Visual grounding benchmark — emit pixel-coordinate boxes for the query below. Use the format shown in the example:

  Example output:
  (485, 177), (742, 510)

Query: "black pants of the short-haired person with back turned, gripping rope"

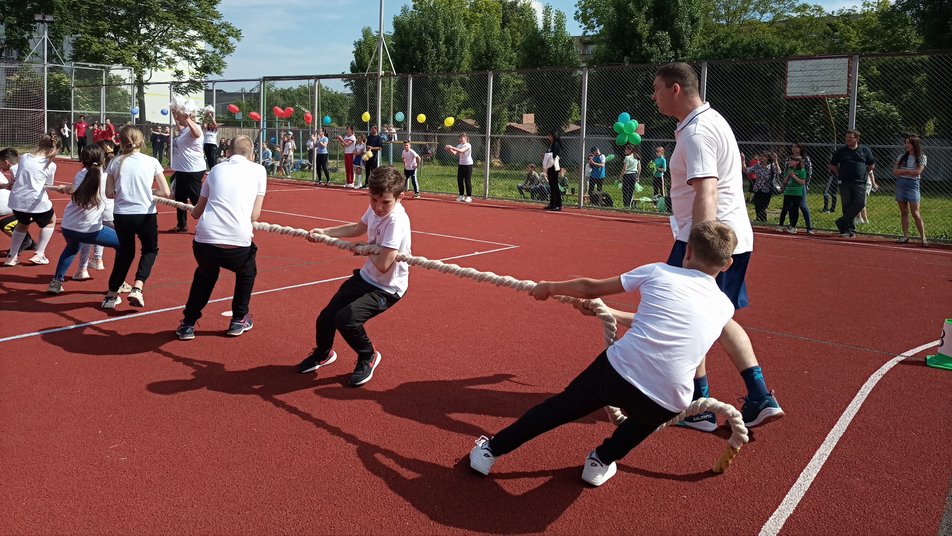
(185, 242), (258, 324)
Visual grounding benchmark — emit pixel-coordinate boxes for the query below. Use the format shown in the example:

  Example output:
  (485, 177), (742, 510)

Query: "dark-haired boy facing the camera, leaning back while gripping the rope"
(298, 167), (410, 387)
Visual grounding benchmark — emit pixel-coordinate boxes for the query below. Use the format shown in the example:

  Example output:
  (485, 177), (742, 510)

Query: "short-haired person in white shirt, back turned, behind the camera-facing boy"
(175, 136), (268, 341)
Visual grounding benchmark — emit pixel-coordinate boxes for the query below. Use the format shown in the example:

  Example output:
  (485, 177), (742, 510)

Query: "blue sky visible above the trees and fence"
(219, 0), (861, 78)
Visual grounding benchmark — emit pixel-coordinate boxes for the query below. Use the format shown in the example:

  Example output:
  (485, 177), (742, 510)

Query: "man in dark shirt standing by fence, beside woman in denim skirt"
(830, 129), (876, 238)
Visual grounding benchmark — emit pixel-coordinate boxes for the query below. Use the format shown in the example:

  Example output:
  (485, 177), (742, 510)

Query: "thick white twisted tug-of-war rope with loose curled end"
(155, 197), (749, 472)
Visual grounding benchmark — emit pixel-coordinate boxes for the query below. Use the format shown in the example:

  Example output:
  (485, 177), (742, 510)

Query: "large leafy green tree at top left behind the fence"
(67, 0), (241, 116)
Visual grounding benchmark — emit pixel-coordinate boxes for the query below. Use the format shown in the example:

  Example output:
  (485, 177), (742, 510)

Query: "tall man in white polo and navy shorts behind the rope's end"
(651, 63), (783, 431)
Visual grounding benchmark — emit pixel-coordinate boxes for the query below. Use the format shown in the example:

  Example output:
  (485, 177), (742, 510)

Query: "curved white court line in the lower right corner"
(760, 340), (939, 536)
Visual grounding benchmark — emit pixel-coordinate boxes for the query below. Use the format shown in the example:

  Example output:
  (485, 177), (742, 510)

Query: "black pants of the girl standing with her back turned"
(109, 214), (159, 292)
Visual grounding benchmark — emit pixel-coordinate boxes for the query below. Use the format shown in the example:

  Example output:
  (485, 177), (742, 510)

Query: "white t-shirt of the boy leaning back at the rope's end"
(608, 263), (734, 413)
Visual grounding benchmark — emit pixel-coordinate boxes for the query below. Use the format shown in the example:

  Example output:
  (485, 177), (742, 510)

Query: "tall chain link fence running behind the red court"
(0, 52), (952, 240)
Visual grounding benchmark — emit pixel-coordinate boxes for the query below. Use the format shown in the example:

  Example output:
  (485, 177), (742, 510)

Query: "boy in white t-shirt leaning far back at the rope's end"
(469, 221), (737, 486)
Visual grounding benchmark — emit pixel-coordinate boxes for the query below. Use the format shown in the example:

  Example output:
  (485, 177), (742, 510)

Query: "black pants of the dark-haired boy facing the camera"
(316, 270), (400, 359)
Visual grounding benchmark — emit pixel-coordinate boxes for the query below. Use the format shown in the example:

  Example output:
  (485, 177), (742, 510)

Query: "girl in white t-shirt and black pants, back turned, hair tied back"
(102, 125), (171, 309)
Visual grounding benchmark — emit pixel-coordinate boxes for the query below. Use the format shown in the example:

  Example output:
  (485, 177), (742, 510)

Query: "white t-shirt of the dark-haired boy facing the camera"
(360, 203), (410, 296)
